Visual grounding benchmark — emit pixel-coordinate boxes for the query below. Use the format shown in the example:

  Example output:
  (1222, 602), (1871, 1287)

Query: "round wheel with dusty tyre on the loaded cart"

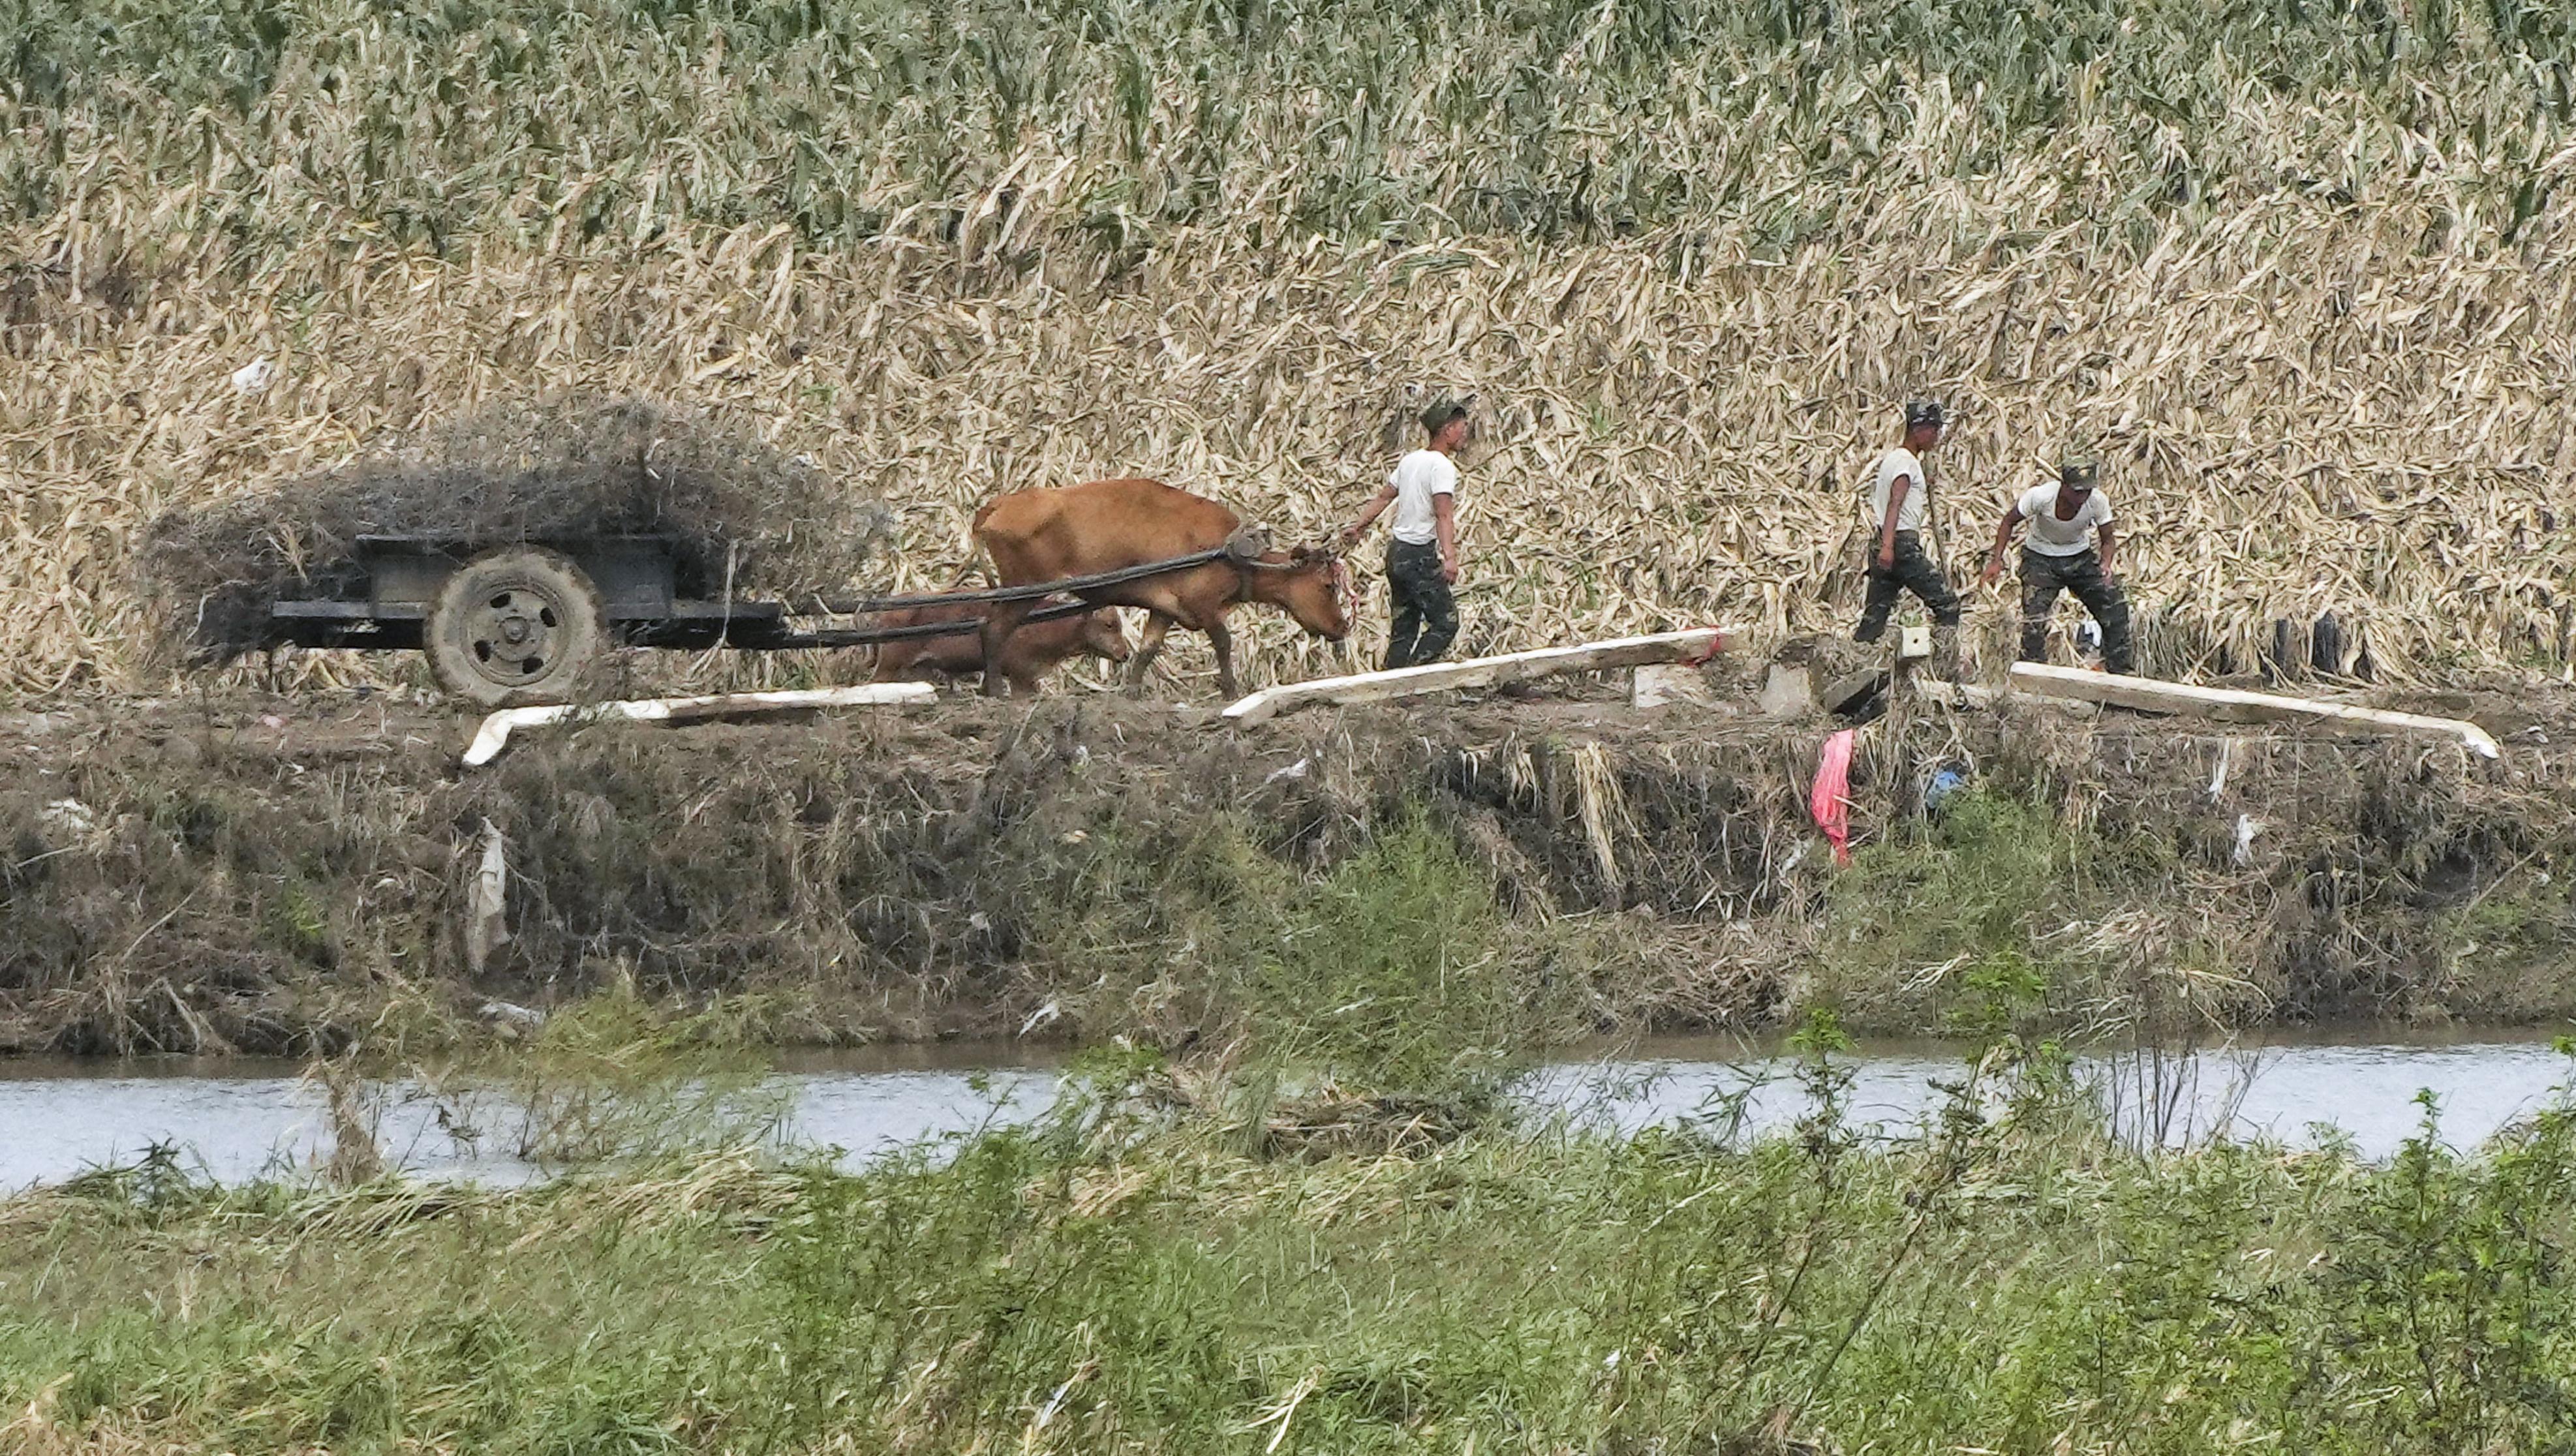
(438, 546), (603, 708)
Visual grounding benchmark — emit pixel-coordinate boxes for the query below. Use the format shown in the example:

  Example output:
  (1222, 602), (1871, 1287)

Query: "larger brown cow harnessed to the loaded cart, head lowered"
(974, 479), (1350, 699)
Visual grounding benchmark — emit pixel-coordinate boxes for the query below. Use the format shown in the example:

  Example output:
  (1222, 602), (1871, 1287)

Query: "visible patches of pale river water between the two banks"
(0, 1033), (2571, 1191)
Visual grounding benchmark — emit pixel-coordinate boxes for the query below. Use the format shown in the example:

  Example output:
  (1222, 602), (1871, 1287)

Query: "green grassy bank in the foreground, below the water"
(0, 1040), (2576, 1456)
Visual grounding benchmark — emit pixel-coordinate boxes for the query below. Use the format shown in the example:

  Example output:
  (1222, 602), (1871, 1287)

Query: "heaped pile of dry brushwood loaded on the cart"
(139, 397), (894, 662)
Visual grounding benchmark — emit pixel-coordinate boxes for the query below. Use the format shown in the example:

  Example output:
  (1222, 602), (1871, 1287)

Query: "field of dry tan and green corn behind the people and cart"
(0, 0), (2576, 696)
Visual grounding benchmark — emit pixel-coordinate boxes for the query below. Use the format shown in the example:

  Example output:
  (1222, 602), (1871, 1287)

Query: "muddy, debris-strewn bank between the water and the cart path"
(0, 696), (2576, 1054)
